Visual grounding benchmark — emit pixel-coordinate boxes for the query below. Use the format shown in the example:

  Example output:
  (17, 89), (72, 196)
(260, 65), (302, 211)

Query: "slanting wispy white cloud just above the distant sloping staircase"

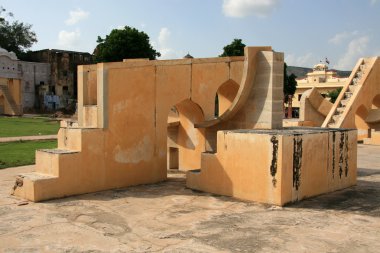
(334, 36), (369, 70)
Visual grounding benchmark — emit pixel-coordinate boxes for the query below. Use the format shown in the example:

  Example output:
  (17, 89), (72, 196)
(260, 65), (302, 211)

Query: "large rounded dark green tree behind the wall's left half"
(94, 26), (161, 62)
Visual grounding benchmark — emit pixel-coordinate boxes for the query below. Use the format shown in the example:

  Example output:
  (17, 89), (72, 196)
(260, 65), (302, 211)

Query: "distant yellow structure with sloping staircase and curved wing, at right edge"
(300, 57), (380, 145)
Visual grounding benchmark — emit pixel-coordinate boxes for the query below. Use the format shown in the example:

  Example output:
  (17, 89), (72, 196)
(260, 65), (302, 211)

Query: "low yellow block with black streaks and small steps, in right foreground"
(187, 128), (357, 205)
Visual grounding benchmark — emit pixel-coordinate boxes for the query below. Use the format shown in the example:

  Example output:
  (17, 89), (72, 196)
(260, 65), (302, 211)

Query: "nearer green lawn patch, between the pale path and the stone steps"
(0, 140), (57, 169)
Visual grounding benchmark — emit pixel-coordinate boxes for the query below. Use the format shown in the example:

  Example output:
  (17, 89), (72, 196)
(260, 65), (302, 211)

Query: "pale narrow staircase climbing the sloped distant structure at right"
(322, 58), (371, 128)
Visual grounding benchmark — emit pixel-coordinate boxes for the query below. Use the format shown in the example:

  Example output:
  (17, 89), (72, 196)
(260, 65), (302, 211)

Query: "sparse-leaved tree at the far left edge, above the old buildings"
(0, 6), (37, 59)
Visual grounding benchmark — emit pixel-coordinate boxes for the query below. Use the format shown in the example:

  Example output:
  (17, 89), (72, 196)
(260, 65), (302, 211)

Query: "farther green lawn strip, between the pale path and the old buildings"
(0, 117), (59, 137)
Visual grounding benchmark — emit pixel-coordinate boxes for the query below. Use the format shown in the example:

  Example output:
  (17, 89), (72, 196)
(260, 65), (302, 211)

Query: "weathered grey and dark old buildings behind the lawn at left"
(0, 48), (93, 115)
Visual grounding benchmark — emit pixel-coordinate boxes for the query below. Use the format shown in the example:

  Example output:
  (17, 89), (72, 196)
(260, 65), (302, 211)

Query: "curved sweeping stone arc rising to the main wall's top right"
(195, 46), (272, 128)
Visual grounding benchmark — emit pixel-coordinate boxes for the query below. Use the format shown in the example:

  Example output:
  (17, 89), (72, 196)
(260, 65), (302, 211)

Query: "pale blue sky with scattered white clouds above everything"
(0, 0), (380, 70)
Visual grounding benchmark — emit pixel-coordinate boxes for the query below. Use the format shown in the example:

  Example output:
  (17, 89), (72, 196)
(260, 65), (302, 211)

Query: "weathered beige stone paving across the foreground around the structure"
(0, 145), (380, 253)
